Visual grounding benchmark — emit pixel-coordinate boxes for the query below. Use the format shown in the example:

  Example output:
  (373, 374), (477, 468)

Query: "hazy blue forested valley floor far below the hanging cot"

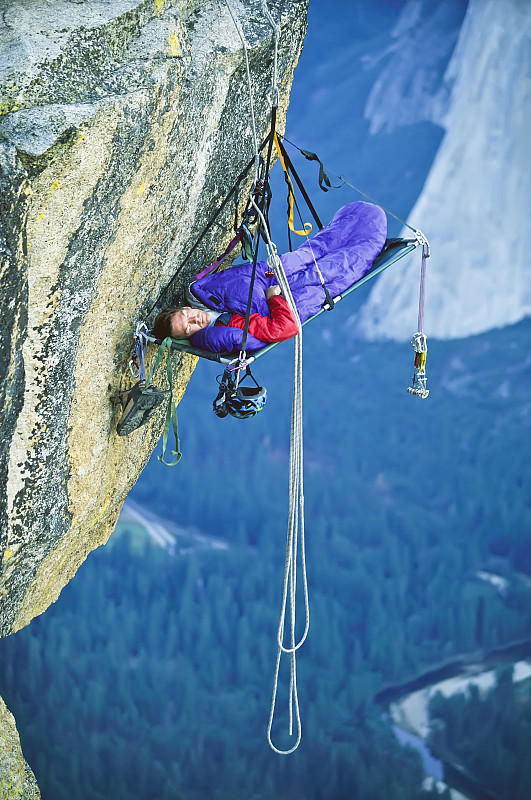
(0, 320), (531, 800)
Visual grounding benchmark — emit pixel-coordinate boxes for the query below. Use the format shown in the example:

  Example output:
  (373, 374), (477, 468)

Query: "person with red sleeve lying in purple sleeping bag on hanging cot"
(153, 202), (387, 352)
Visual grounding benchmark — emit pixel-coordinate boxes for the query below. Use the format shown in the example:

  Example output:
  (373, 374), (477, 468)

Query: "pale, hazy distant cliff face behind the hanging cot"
(355, 0), (531, 340)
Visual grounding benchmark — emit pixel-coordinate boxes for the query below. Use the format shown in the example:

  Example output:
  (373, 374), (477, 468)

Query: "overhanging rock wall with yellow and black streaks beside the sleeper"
(0, 0), (307, 635)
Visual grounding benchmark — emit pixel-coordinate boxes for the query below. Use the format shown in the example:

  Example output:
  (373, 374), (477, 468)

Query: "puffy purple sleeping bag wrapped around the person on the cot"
(190, 202), (387, 352)
